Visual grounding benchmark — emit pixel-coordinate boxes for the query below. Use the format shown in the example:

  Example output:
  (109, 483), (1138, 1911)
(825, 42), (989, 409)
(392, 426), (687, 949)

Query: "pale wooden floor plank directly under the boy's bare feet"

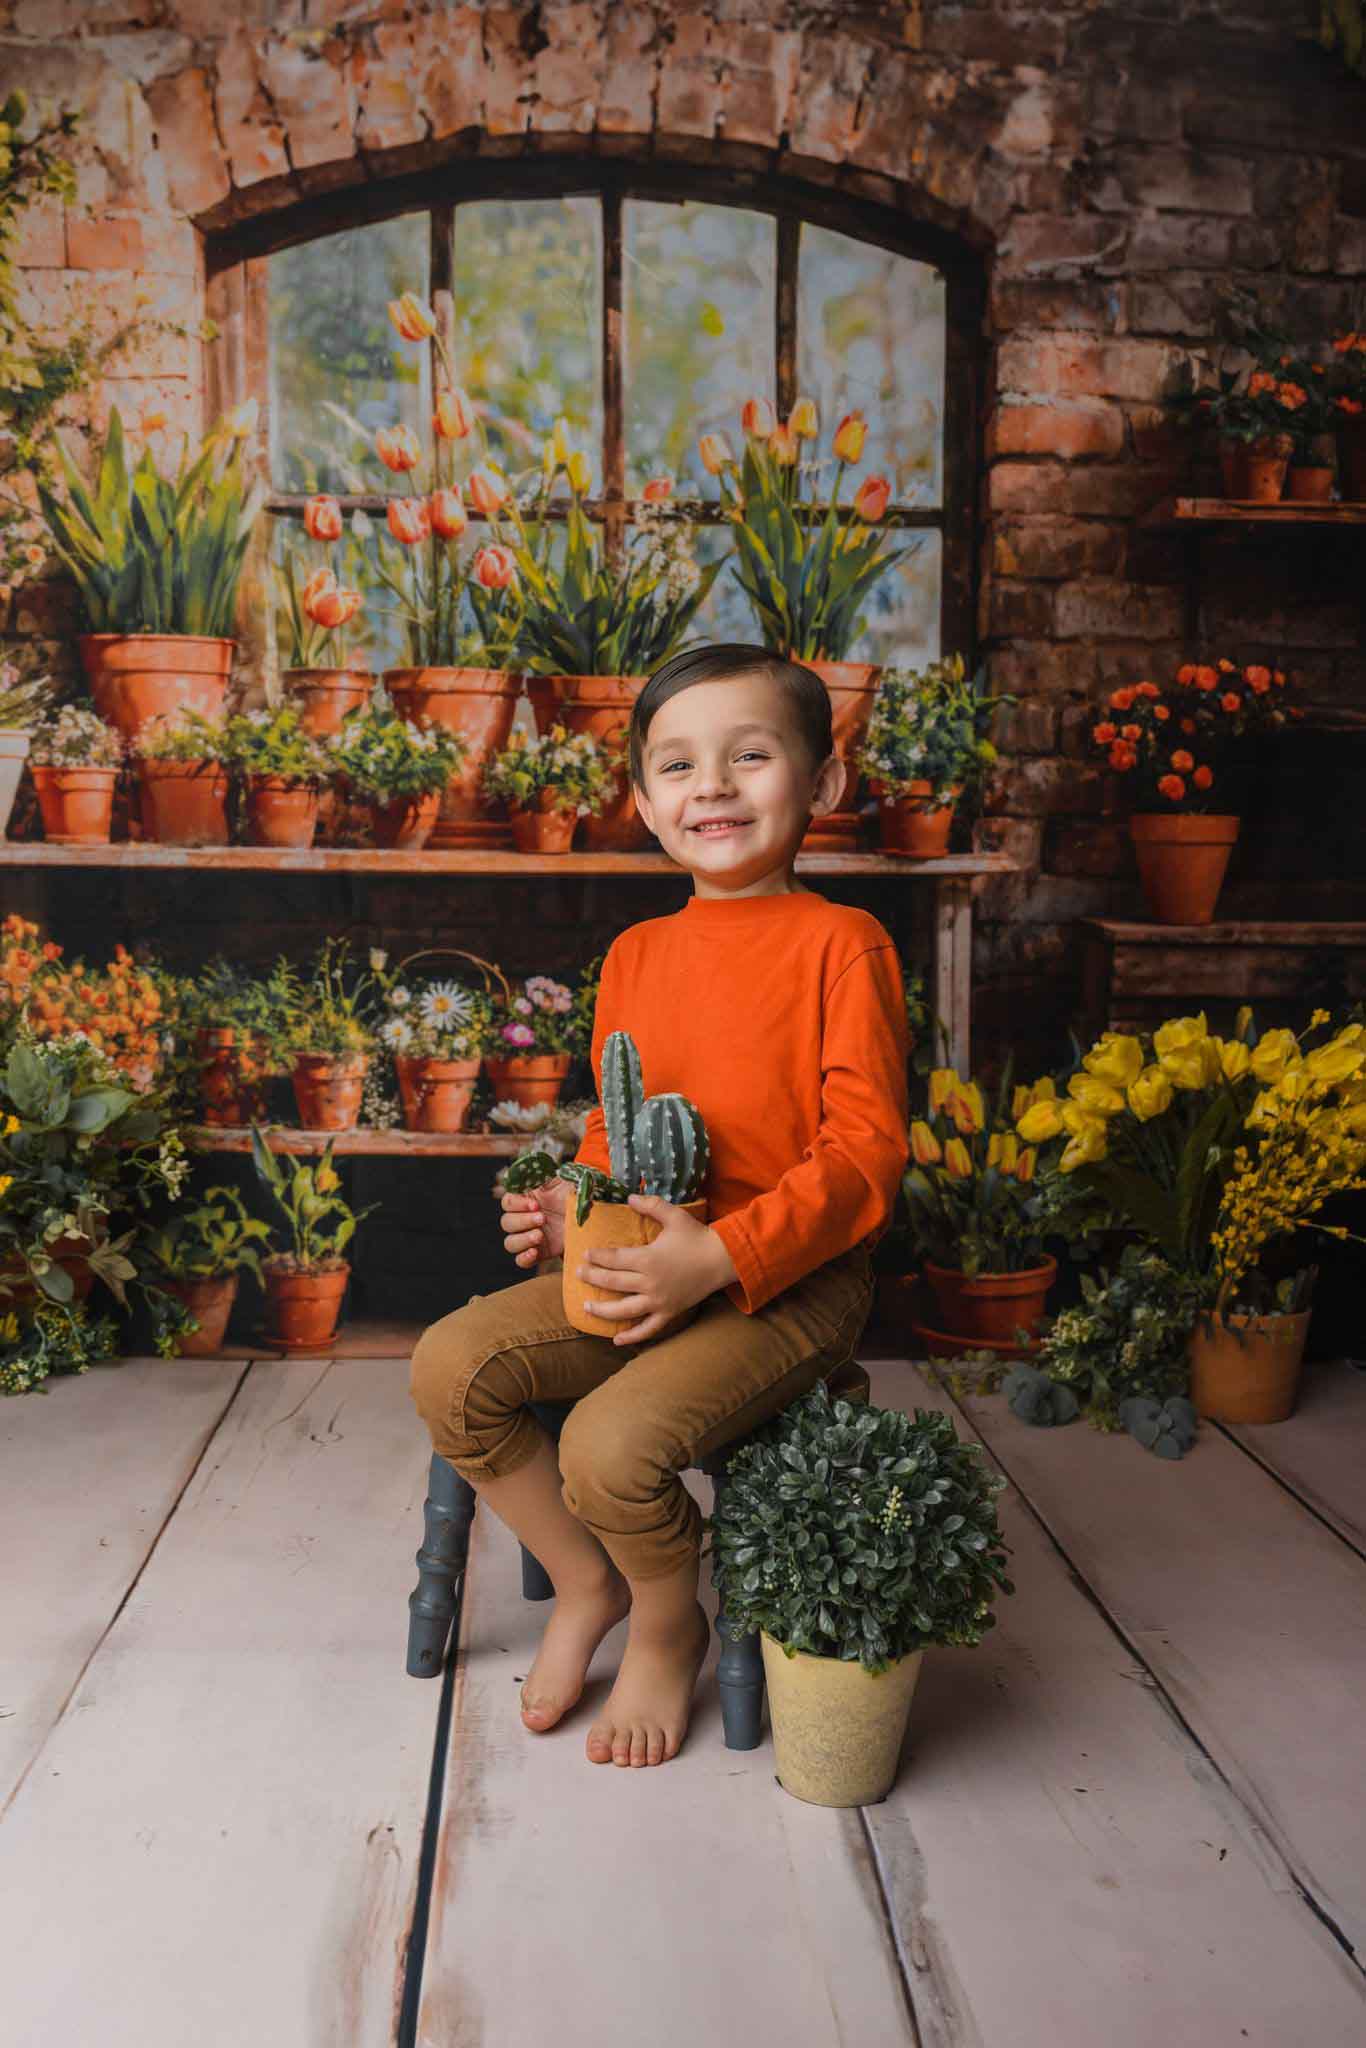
(418, 1473), (913, 2048)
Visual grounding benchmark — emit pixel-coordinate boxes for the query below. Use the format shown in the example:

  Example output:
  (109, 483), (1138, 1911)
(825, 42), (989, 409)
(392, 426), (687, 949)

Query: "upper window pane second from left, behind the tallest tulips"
(455, 199), (602, 489)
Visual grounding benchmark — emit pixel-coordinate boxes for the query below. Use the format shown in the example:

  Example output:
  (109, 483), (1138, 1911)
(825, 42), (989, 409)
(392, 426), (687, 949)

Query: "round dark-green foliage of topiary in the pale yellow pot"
(711, 1382), (1014, 1671)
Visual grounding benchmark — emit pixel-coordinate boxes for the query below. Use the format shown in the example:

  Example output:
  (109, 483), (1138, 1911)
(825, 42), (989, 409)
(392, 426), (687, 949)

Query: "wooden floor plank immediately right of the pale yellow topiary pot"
(866, 1360), (1366, 2048)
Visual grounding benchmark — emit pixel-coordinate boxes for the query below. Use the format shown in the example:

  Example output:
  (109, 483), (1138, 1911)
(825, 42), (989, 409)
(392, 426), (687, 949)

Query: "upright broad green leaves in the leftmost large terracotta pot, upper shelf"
(39, 406), (266, 637)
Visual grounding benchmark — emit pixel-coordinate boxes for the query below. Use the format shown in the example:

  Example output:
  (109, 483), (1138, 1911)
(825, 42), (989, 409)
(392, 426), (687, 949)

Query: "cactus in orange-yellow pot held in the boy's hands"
(555, 1030), (711, 1337)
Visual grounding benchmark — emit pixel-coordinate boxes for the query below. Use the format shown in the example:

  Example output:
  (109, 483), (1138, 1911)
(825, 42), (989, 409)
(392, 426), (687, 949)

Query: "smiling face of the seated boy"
(635, 674), (844, 893)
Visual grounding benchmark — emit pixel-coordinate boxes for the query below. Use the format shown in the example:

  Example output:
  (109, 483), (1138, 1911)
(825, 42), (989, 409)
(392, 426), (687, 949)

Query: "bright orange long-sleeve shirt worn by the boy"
(575, 889), (909, 1315)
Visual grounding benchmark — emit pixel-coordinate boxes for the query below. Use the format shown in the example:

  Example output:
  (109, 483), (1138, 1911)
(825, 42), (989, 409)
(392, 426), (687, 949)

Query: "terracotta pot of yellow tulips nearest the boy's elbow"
(901, 1067), (1057, 1350)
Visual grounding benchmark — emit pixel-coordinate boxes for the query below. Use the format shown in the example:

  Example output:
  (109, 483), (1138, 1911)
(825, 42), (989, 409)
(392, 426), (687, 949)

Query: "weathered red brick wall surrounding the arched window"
(0, 0), (1366, 1059)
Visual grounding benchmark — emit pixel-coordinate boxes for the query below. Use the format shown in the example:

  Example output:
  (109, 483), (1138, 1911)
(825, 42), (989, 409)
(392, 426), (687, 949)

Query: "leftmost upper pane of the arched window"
(268, 213), (428, 492)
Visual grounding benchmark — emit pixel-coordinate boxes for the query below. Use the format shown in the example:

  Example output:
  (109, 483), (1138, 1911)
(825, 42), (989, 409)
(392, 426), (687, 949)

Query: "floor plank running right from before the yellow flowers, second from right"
(933, 1359), (1366, 1964)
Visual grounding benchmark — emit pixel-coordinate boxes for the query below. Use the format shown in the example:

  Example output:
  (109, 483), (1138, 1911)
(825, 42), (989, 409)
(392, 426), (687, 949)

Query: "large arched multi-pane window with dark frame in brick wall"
(209, 160), (977, 664)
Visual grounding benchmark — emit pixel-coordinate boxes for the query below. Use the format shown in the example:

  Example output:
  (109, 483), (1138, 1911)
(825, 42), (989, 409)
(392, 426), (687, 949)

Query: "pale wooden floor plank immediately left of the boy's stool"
(0, 1360), (440, 2048)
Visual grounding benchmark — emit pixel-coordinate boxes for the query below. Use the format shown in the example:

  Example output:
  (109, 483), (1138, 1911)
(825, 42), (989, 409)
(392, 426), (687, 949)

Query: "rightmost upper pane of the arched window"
(797, 223), (946, 506)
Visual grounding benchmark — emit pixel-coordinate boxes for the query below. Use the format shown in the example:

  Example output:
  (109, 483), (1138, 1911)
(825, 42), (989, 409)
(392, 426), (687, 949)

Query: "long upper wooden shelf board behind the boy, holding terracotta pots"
(0, 840), (1016, 881)
